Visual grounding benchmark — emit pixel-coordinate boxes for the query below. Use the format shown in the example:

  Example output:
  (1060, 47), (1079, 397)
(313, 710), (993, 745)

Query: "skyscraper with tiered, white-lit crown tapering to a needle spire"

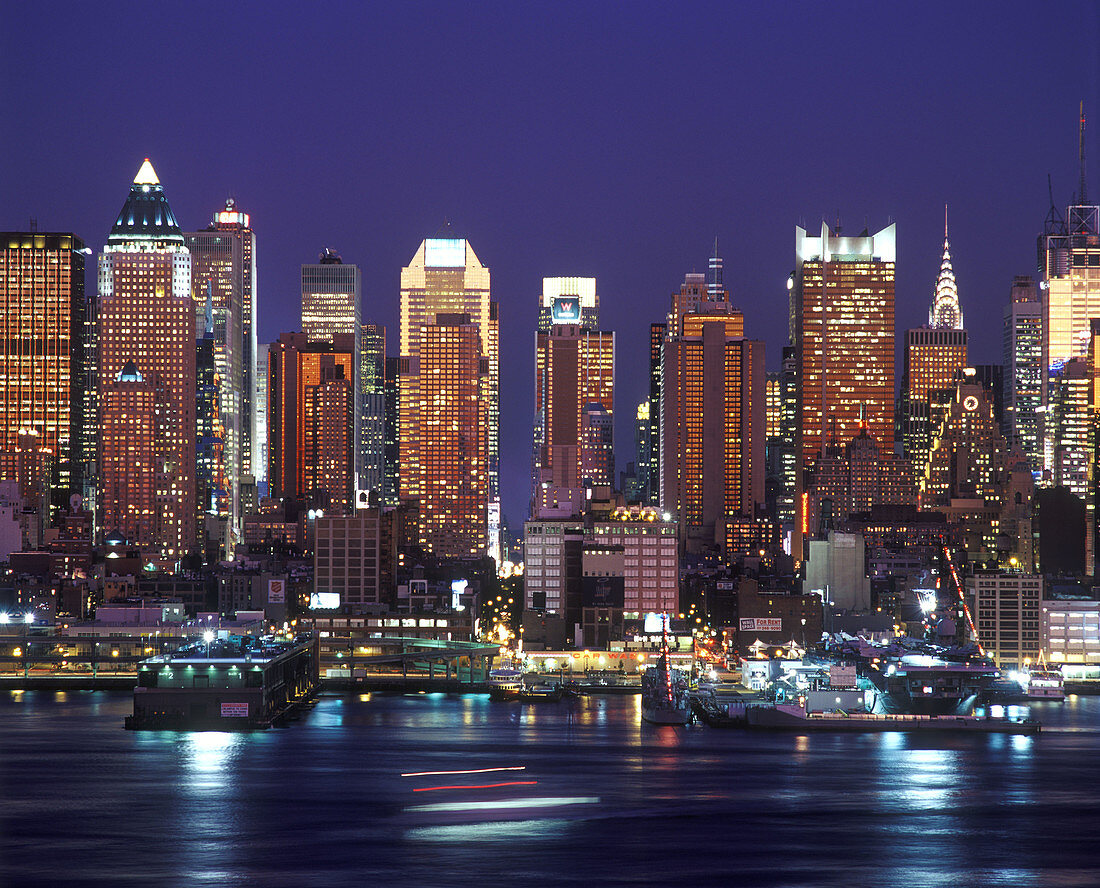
(899, 214), (967, 475)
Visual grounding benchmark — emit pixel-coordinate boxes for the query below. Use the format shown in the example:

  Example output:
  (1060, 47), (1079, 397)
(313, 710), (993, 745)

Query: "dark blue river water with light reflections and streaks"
(0, 692), (1100, 888)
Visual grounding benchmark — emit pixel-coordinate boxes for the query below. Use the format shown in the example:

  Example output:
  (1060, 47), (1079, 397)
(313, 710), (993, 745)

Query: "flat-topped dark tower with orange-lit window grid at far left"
(0, 231), (86, 511)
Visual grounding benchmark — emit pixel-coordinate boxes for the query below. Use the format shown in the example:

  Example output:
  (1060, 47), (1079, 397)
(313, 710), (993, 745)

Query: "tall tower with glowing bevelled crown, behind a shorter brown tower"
(398, 238), (501, 556)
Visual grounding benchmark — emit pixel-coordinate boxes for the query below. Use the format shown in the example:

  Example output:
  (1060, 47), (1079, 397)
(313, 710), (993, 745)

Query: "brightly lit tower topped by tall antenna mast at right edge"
(1038, 103), (1100, 472)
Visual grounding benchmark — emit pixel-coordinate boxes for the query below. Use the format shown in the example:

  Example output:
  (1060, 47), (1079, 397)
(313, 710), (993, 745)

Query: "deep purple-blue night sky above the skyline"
(0, 0), (1100, 529)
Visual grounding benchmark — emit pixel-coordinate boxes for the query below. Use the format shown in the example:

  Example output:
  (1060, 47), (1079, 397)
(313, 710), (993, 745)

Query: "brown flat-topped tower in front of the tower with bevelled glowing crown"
(402, 314), (490, 557)
